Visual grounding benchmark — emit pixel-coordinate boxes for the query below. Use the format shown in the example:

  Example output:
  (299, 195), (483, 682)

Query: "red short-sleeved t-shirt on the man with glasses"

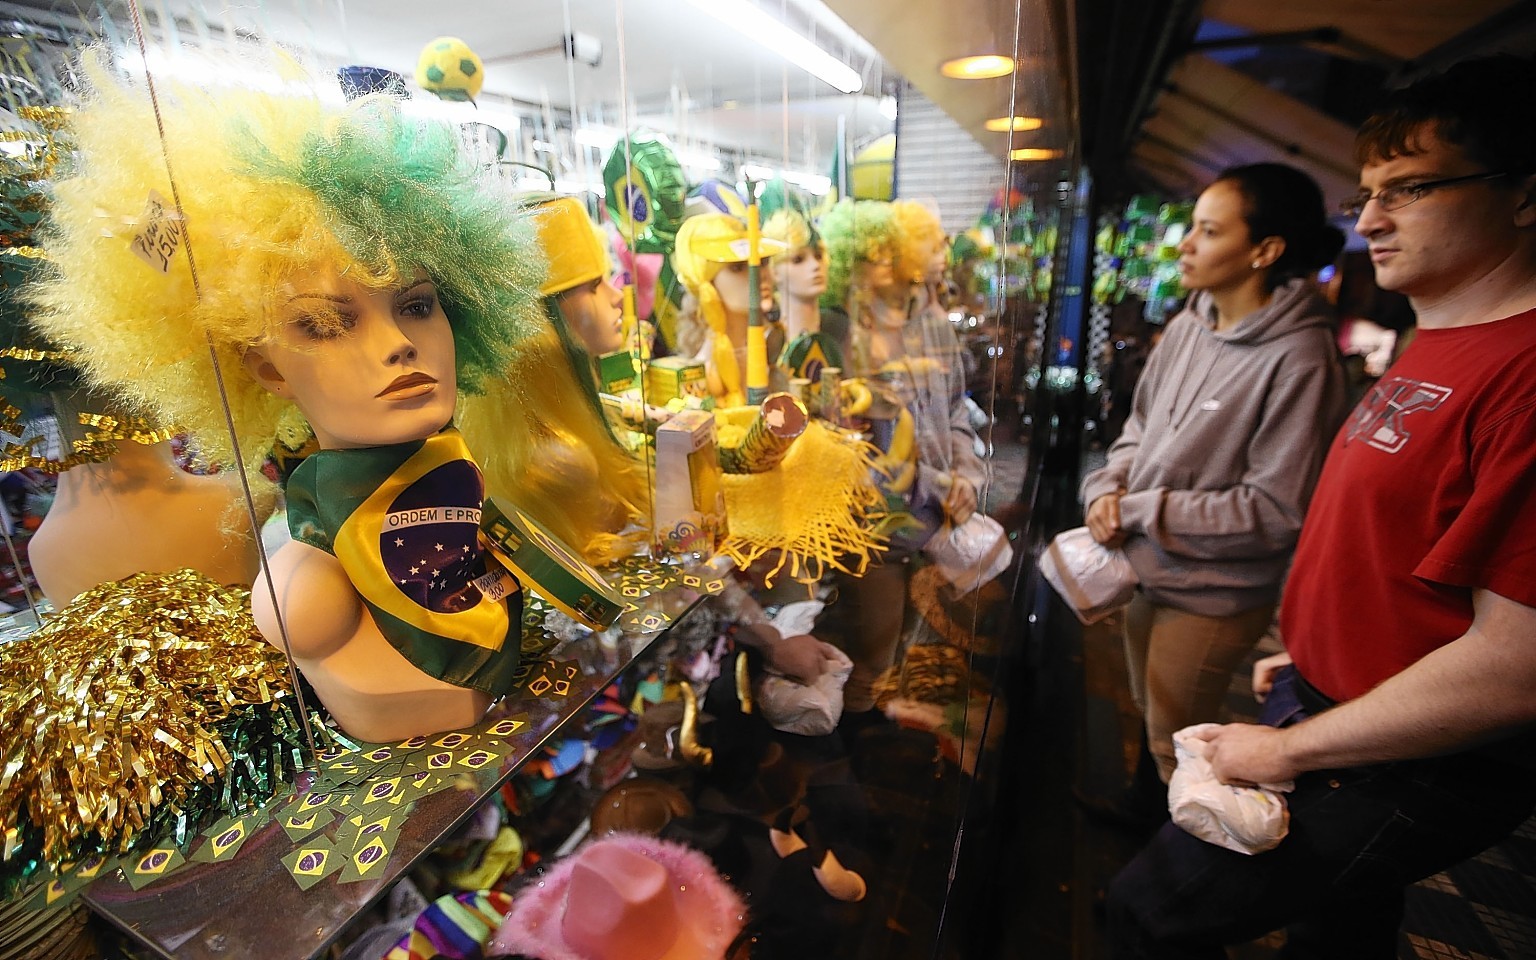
(1281, 310), (1536, 700)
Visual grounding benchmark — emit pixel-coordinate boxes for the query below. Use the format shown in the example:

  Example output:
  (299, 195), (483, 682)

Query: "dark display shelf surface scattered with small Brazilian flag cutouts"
(83, 571), (705, 960)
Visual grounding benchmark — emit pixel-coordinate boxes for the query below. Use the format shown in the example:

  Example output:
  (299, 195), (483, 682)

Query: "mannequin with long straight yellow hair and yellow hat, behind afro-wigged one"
(458, 197), (650, 567)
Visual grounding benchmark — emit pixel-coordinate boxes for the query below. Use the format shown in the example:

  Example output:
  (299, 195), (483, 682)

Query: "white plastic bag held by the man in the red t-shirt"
(1167, 723), (1295, 854)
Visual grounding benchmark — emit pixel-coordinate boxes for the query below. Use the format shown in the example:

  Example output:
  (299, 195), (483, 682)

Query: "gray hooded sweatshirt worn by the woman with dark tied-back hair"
(1083, 278), (1346, 616)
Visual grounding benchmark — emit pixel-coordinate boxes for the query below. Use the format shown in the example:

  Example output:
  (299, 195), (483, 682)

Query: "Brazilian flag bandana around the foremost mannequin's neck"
(286, 427), (522, 696)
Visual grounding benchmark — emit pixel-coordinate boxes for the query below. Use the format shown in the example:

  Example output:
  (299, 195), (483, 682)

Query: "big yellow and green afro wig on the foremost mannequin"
(31, 51), (544, 462)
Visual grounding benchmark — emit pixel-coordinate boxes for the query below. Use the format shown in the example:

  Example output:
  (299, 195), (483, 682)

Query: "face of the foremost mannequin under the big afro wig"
(244, 264), (458, 450)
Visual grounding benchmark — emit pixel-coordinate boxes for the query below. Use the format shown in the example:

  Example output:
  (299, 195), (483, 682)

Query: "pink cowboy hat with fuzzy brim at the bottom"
(487, 833), (746, 960)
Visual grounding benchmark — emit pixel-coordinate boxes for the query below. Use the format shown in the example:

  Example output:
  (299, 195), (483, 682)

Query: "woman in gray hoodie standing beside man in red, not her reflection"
(1083, 163), (1346, 797)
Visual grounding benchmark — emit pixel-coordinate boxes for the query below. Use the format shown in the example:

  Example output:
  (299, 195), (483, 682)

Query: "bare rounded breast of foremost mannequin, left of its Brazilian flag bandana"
(250, 541), (366, 659)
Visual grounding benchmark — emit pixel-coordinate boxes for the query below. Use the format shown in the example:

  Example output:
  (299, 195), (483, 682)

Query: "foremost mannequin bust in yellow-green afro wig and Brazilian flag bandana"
(32, 54), (542, 742)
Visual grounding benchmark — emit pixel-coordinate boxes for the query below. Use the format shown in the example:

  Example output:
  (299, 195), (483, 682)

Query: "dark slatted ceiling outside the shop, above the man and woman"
(1077, 0), (1536, 206)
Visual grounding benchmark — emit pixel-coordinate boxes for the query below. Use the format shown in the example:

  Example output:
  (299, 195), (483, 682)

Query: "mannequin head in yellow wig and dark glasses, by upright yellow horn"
(673, 214), (783, 407)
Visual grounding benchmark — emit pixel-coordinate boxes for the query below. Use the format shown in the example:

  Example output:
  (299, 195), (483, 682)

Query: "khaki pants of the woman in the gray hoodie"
(1126, 593), (1275, 783)
